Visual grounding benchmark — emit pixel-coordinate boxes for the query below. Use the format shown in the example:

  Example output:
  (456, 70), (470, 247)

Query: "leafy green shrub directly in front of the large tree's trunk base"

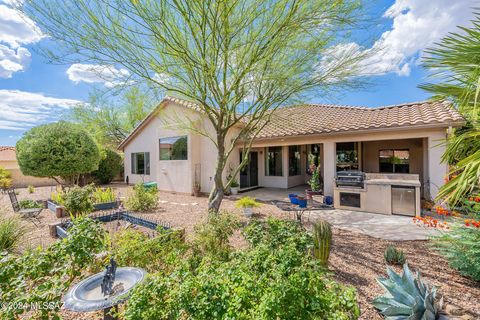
(195, 211), (240, 260)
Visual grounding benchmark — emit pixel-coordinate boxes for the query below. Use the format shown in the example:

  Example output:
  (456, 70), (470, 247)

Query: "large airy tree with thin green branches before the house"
(19, 0), (365, 211)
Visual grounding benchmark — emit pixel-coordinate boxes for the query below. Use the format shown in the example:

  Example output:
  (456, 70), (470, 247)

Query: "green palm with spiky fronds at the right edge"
(421, 12), (480, 205)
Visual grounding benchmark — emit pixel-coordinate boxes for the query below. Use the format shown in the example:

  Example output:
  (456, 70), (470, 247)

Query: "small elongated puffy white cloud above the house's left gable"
(67, 63), (130, 88)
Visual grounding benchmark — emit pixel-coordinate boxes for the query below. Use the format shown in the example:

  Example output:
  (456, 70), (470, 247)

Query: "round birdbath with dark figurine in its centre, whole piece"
(64, 258), (147, 320)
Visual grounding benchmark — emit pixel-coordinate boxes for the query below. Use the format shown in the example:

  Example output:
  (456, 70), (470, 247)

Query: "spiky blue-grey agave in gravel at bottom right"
(372, 263), (442, 320)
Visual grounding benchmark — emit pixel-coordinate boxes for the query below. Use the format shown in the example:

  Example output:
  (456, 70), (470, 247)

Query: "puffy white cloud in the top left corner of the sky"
(0, 0), (44, 78)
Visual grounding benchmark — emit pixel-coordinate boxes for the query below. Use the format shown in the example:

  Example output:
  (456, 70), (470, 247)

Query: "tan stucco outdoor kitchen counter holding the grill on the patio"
(334, 173), (421, 216)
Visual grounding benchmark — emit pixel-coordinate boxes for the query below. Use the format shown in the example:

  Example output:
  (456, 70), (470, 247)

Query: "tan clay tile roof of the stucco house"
(118, 97), (464, 149)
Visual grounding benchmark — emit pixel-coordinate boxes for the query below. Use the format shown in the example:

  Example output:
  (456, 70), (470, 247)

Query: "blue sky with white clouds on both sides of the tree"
(0, 0), (480, 145)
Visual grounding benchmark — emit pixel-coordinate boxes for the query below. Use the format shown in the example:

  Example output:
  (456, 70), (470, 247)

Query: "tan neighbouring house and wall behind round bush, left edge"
(0, 146), (56, 187)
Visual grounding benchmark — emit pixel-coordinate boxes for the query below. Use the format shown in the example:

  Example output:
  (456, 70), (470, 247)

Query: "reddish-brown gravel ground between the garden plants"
(0, 185), (480, 319)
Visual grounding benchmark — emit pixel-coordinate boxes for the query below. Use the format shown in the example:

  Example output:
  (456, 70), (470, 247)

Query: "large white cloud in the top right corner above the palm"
(354, 0), (474, 76)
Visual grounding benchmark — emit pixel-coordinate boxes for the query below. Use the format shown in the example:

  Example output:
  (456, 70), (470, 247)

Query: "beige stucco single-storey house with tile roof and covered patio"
(119, 97), (464, 212)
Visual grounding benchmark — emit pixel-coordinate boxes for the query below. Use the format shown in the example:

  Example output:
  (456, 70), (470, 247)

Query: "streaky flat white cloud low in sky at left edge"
(0, 90), (81, 130)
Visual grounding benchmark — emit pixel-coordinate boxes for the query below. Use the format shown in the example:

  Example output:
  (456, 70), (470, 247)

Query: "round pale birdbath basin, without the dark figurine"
(63, 267), (147, 312)
